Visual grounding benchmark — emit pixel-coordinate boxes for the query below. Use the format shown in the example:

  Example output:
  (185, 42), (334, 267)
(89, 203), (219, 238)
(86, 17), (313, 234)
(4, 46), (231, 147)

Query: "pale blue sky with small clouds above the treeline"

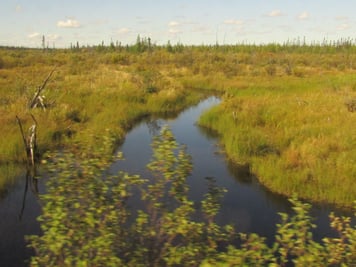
(0, 0), (356, 48)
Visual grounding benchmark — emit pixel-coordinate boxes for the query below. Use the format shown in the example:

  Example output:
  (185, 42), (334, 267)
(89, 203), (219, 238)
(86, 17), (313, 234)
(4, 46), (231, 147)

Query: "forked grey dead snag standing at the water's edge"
(16, 114), (37, 166)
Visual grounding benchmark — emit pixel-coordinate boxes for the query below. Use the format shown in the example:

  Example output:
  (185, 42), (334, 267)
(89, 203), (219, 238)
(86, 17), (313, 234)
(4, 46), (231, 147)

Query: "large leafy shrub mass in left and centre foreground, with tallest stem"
(30, 128), (232, 266)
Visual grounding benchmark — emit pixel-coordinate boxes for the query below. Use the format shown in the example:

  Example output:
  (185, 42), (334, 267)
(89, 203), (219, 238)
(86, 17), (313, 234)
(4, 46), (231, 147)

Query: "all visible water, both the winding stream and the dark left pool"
(0, 98), (352, 267)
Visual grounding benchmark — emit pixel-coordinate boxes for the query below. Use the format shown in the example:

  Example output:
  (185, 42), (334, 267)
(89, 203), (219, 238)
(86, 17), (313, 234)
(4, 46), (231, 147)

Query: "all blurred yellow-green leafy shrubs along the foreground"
(29, 128), (356, 266)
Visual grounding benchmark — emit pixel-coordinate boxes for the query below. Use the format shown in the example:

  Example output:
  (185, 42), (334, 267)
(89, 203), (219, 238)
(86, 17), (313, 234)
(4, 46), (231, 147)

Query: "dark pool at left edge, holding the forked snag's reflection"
(0, 171), (44, 267)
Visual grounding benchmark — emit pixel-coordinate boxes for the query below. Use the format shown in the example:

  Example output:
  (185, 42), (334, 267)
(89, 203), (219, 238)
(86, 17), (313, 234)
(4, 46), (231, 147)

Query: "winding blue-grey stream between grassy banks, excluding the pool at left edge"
(112, 97), (352, 243)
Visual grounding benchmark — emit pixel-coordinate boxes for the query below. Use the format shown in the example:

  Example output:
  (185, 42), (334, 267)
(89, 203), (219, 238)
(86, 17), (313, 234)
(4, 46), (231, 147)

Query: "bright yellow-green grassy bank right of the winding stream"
(200, 73), (356, 209)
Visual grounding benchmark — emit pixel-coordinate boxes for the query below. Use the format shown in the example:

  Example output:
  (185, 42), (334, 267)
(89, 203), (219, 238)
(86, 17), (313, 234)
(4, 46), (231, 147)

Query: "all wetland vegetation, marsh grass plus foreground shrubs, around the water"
(0, 39), (356, 266)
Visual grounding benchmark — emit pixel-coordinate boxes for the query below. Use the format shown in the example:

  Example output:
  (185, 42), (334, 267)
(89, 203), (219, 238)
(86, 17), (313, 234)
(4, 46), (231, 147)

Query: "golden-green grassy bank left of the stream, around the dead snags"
(0, 49), (210, 162)
